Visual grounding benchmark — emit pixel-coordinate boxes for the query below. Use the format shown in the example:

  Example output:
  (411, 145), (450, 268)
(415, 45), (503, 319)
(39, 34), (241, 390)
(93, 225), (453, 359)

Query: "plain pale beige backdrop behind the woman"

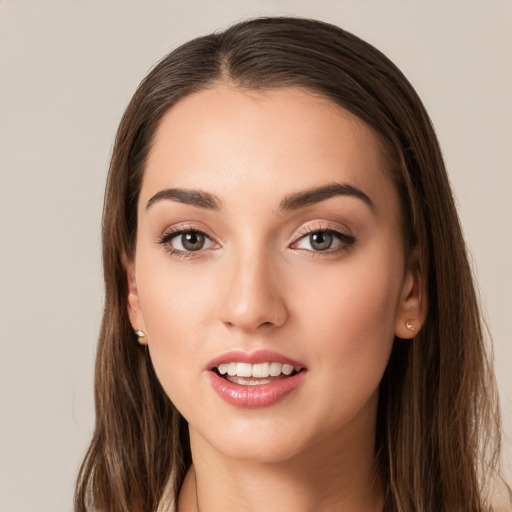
(0, 0), (512, 512)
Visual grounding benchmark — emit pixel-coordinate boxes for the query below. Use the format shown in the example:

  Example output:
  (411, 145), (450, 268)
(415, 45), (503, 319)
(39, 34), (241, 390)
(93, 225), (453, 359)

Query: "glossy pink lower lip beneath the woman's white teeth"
(208, 370), (306, 409)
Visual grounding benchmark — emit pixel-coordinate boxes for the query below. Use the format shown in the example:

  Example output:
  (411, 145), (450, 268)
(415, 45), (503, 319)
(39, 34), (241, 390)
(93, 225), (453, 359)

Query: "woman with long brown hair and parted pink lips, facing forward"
(76, 18), (506, 512)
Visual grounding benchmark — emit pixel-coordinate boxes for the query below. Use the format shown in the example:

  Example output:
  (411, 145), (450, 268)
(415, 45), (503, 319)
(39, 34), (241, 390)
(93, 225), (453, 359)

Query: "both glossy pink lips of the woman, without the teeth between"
(205, 350), (307, 409)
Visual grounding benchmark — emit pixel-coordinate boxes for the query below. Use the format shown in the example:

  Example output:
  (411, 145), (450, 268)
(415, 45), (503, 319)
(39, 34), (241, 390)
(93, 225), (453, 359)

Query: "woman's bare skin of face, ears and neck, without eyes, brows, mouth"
(127, 84), (425, 512)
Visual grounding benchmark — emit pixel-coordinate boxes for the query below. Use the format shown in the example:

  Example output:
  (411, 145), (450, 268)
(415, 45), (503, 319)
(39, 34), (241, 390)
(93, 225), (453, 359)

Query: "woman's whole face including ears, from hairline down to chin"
(128, 85), (420, 461)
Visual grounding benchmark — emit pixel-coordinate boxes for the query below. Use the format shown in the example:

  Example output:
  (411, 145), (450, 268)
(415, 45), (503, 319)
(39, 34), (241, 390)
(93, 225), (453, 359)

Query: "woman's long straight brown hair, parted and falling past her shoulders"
(75, 18), (499, 512)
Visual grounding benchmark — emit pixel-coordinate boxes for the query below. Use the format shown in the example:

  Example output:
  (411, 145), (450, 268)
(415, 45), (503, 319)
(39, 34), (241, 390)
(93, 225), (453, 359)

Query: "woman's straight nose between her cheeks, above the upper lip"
(221, 247), (289, 333)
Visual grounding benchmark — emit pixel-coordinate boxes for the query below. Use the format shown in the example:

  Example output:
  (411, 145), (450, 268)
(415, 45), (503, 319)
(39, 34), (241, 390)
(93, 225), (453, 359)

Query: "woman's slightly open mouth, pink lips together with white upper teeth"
(205, 350), (307, 408)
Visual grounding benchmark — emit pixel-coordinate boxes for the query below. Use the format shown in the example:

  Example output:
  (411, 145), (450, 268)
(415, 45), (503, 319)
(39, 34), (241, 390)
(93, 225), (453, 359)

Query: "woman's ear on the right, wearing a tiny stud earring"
(395, 248), (427, 339)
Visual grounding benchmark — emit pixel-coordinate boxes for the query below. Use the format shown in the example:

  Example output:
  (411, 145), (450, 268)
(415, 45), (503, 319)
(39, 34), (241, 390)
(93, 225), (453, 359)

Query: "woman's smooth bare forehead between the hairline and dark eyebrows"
(141, 85), (397, 216)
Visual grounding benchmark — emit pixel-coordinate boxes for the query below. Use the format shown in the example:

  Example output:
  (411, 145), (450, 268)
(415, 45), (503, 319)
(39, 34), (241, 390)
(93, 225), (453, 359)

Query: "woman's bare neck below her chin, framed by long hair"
(178, 422), (383, 512)
